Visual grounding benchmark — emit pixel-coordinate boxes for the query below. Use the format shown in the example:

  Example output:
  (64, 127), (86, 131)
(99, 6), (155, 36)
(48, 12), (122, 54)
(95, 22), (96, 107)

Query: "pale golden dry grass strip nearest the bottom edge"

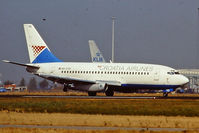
(0, 112), (199, 129)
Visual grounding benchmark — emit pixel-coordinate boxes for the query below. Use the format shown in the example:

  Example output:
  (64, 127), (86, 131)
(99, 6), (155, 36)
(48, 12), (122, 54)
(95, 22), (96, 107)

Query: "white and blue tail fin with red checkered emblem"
(24, 24), (62, 63)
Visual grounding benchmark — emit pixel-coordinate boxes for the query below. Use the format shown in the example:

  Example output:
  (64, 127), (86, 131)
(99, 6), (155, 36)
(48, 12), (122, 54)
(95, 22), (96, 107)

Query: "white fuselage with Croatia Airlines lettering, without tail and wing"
(35, 62), (188, 89)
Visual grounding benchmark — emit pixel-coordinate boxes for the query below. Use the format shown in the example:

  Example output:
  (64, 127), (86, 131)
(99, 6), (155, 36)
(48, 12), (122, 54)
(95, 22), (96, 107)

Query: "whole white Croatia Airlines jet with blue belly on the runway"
(3, 24), (189, 96)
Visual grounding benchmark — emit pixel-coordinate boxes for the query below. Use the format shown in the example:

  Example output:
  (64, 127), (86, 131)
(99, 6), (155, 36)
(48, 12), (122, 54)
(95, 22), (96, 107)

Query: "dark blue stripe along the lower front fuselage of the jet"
(122, 84), (179, 89)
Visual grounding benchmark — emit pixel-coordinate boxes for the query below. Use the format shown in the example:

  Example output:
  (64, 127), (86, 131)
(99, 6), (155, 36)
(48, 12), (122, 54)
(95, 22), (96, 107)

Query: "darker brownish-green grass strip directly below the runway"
(0, 98), (199, 117)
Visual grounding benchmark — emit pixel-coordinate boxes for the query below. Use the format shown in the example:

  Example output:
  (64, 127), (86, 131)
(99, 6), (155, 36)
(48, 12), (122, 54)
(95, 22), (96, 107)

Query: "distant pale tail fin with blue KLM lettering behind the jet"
(88, 40), (106, 62)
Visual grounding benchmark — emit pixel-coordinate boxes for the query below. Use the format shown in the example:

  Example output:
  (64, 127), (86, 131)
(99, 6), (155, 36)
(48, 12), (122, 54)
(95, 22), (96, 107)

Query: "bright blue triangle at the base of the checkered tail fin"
(32, 48), (62, 63)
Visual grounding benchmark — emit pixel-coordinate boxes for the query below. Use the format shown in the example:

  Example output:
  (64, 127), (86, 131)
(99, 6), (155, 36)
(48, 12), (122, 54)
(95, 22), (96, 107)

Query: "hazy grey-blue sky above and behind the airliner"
(0, 0), (199, 82)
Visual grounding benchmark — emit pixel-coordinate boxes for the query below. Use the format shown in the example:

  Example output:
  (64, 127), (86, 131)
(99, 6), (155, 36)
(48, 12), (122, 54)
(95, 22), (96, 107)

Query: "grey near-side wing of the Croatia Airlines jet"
(38, 74), (121, 86)
